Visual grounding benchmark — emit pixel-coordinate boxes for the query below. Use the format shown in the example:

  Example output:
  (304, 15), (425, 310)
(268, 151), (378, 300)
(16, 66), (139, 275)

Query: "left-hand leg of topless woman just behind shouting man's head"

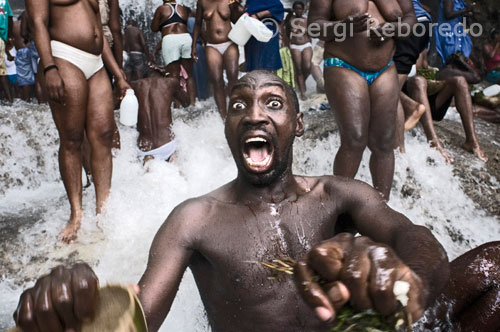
(205, 46), (226, 119)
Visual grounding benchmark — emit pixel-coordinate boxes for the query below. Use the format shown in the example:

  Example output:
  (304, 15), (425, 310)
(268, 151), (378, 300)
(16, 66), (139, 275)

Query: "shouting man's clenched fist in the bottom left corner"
(14, 264), (99, 332)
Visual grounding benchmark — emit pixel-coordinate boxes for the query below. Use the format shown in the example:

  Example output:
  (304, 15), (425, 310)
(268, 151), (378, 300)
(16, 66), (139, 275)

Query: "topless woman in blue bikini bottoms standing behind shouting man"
(308, 0), (416, 199)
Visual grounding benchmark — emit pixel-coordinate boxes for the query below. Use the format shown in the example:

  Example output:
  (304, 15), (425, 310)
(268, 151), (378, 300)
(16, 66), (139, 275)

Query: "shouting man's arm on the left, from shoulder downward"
(139, 200), (203, 332)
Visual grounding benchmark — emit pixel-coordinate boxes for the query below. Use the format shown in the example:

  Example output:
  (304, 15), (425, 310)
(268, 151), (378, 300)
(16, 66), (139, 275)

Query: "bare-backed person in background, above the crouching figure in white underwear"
(123, 20), (150, 82)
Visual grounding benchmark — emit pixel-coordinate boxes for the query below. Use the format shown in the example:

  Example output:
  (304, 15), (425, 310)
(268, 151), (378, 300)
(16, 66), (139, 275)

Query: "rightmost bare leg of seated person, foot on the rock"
(436, 76), (488, 162)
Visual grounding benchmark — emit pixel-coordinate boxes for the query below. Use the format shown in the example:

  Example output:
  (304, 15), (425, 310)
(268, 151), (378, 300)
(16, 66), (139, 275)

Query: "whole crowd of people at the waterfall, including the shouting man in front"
(0, 0), (500, 332)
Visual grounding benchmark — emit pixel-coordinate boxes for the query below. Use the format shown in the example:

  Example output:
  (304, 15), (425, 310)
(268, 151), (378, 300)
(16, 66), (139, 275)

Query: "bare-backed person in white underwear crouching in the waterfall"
(131, 70), (189, 161)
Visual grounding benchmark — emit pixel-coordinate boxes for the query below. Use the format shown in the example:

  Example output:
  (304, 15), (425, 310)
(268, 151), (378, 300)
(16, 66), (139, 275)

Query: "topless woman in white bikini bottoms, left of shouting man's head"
(192, 0), (240, 118)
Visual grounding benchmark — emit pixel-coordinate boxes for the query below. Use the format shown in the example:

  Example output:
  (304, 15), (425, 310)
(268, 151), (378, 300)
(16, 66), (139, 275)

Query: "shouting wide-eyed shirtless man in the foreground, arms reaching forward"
(12, 71), (448, 332)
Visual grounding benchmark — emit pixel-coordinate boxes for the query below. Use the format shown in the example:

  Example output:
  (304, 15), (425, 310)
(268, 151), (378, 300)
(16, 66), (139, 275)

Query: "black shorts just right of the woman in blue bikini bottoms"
(394, 21), (431, 75)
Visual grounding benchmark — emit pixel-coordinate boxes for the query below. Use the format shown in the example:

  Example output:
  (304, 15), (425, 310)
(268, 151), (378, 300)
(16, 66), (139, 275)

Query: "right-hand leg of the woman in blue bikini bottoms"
(368, 64), (400, 200)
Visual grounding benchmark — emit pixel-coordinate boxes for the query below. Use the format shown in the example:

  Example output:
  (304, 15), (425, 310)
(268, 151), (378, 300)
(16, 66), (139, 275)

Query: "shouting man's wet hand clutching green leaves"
(295, 233), (427, 322)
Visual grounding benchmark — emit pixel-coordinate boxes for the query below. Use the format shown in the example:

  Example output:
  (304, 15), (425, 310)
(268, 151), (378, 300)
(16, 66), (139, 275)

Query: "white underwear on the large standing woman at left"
(50, 40), (104, 79)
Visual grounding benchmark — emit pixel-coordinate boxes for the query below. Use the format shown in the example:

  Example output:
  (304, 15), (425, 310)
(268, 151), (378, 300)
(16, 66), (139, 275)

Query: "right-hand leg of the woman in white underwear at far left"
(86, 68), (115, 214)
